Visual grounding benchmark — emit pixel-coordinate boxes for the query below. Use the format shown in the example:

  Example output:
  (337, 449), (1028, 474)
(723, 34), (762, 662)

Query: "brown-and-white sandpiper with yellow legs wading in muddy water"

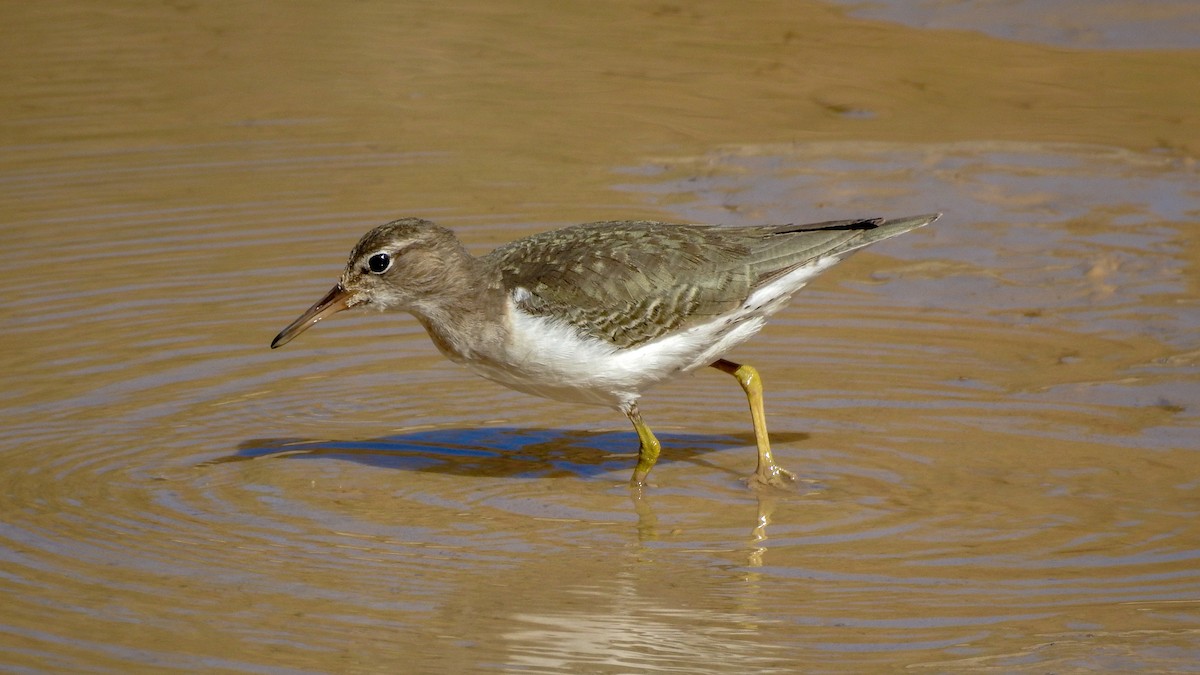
(271, 214), (941, 486)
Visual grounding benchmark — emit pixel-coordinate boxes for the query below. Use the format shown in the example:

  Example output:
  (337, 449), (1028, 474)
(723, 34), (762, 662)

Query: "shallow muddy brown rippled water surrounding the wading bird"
(0, 2), (1200, 673)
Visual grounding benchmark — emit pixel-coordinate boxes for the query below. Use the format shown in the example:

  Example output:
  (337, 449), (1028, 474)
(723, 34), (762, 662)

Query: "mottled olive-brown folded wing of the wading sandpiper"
(488, 216), (936, 347)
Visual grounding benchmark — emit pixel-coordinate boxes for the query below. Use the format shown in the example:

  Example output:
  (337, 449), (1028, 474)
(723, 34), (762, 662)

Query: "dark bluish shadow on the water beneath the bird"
(218, 426), (809, 478)
